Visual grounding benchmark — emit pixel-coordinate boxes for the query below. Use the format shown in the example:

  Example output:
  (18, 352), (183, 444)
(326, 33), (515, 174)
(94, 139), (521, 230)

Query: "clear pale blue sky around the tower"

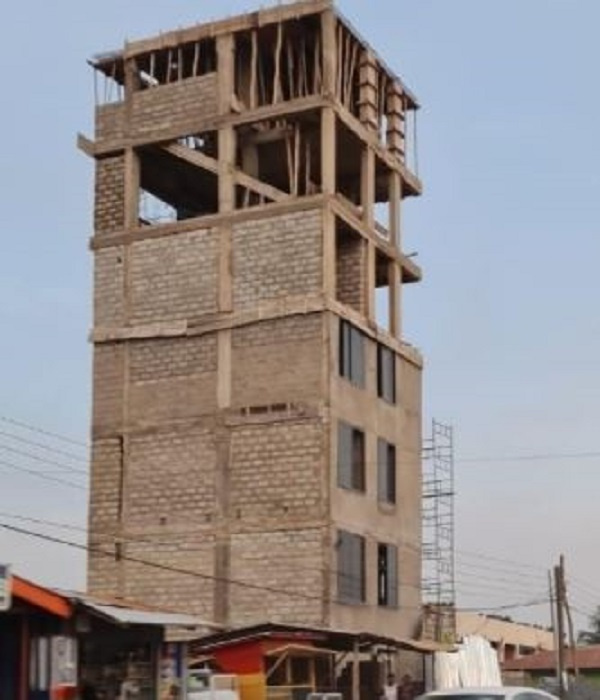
(0, 0), (600, 620)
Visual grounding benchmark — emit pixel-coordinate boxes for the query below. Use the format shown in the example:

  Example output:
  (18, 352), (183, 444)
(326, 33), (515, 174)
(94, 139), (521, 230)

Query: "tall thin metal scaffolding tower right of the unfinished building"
(423, 420), (456, 641)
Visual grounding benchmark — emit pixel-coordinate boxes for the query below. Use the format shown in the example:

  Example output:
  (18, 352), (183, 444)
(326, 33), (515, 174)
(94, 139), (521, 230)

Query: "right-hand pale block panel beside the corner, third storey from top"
(233, 210), (323, 309)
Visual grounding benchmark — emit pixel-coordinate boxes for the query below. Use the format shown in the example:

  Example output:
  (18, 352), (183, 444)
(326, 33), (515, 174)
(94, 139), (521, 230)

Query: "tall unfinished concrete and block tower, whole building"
(79, 0), (422, 637)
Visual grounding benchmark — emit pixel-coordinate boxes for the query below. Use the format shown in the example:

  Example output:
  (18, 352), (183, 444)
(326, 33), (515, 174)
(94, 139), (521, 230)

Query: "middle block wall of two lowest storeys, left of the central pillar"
(125, 428), (216, 619)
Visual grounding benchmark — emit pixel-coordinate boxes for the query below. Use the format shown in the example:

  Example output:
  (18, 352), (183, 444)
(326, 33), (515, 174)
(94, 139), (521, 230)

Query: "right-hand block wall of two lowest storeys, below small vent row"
(229, 420), (325, 624)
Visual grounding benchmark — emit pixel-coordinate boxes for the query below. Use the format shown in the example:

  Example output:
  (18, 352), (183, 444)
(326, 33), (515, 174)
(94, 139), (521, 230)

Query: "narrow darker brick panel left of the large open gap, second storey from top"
(94, 155), (125, 234)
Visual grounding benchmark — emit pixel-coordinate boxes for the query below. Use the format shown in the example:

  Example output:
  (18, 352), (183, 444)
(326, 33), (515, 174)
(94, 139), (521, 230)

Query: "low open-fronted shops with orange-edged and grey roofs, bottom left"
(0, 576), (214, 700)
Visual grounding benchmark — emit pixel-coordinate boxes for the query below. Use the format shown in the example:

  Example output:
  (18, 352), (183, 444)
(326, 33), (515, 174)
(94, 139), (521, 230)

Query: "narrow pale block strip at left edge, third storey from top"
(94, 246), (125, 326)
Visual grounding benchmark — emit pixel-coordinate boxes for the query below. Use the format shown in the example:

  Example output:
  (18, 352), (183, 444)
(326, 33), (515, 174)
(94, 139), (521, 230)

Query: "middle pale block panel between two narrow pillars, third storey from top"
(130, 229), (218, 323)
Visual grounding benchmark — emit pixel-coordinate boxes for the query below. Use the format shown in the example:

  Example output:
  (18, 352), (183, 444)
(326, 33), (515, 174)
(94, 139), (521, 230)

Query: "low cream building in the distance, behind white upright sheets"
(456, 612), (554, 663)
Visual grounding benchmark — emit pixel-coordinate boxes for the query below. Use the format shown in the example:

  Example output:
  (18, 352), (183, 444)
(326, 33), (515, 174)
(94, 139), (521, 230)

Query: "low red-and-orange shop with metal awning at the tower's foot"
(189, 623), (448, 700)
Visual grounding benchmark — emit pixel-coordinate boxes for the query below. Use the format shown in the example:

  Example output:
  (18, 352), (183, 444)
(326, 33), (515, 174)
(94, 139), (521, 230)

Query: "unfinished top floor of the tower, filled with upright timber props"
(91, 0), (418, 170)
